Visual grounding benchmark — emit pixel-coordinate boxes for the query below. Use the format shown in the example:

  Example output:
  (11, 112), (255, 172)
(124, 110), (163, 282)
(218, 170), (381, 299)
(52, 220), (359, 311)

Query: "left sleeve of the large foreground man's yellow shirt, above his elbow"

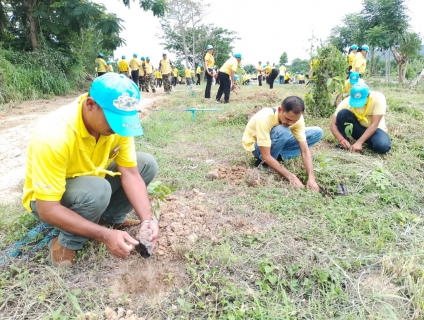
(31, 140), (70, 201)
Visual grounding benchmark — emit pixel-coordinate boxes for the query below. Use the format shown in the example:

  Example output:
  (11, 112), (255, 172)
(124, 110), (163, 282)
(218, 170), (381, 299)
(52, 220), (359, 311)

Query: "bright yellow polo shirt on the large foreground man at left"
(22, 94), (137, 212)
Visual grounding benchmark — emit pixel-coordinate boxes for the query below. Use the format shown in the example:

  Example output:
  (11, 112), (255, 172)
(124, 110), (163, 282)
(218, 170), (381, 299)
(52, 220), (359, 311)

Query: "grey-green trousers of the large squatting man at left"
(31, 152), (158, 250)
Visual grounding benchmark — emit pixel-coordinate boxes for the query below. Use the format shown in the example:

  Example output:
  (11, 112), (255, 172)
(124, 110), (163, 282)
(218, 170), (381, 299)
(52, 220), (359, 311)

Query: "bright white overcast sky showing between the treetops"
(94, 0), (424, 65)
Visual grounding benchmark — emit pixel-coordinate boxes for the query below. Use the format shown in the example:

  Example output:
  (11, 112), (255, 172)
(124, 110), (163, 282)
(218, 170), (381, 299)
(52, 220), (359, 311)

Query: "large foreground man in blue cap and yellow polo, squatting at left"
(22, 73), (159, 267)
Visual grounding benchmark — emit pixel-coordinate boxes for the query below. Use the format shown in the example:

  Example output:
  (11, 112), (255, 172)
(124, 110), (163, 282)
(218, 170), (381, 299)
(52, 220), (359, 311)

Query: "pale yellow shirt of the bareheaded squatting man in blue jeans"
(242, 107), (306, 151)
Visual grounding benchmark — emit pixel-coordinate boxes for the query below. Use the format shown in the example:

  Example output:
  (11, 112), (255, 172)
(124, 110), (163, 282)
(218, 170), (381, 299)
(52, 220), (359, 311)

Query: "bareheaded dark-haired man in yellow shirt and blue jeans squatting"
(242, 96), (323, 191)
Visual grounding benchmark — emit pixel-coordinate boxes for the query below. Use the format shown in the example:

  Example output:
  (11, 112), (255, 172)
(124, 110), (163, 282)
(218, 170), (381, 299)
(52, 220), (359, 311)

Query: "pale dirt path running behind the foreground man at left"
(0, 92), (164, 204)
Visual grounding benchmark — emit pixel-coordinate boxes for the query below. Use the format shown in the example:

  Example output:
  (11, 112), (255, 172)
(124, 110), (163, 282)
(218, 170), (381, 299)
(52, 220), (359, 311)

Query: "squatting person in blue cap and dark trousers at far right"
(330, 82), (391, 154)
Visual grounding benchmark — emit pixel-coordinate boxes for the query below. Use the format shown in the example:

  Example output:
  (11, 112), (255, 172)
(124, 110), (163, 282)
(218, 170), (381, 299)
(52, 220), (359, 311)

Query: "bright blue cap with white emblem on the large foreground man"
(90, 72), (143, 137)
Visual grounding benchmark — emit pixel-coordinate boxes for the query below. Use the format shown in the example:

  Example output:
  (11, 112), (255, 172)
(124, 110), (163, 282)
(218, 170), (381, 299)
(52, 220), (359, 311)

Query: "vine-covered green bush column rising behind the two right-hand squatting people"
(305, 44), (346, 117)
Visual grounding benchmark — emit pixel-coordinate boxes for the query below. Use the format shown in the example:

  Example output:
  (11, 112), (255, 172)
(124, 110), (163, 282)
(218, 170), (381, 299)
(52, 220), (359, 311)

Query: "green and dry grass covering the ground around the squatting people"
(0, 81), (424, 320)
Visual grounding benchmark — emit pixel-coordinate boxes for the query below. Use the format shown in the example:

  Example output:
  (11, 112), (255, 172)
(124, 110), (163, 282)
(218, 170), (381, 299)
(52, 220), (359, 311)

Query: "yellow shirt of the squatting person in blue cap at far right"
(334, 91), (387, 132)
